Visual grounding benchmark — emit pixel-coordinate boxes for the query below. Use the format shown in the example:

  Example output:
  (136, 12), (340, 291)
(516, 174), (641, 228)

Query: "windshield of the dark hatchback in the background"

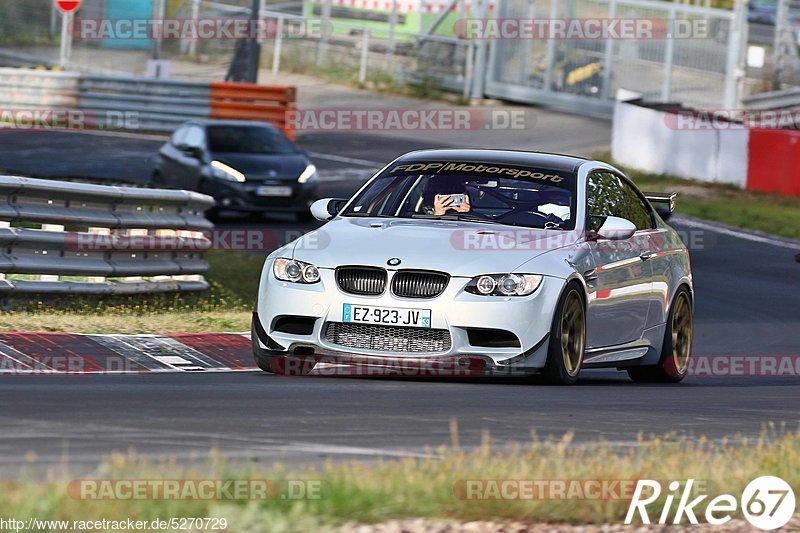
(207, 126), (297, 154)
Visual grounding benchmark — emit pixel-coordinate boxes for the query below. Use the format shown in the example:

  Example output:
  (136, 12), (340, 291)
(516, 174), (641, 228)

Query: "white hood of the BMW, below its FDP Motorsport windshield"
(293, 217), (576, 277)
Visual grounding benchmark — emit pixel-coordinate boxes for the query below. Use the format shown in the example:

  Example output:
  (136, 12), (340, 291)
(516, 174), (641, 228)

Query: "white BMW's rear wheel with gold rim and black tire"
(628, 286), (694, 383)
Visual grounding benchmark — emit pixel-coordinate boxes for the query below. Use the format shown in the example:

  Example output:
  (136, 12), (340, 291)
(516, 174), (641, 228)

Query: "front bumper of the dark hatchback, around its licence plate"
(200, 179), (319, 213)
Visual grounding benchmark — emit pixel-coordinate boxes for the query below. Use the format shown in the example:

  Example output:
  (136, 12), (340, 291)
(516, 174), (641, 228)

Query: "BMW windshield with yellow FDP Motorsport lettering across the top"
(342, 161), (576, 230)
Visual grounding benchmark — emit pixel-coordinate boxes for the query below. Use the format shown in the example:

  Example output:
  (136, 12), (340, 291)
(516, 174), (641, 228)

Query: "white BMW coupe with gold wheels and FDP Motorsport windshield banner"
(252, 150), (694, 384)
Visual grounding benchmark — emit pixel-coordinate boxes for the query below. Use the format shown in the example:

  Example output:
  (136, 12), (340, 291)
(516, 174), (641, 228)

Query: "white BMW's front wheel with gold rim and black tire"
(542, 281), (586, 385)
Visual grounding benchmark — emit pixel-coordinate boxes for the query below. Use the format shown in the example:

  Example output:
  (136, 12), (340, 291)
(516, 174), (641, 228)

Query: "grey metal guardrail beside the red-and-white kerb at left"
(0, 176), (214, 296)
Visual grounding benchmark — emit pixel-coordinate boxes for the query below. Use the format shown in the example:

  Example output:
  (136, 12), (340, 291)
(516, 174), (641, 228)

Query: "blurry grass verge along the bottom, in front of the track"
(0, 428), (800, 532)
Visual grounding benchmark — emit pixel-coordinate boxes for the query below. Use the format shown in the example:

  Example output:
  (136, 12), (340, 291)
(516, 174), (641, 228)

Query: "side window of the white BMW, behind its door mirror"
(586, 172), (653, 231)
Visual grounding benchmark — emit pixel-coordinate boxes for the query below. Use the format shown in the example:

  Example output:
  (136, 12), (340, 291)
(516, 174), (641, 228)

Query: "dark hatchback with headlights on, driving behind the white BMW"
(153, 120), (319, 219)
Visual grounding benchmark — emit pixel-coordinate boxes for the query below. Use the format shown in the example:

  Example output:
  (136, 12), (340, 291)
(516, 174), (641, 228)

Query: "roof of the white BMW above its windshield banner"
(397, 148), (588, 172)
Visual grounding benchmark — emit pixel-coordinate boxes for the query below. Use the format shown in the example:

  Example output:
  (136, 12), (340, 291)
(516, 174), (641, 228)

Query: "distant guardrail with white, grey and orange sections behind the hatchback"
(0, 68), (296, 139)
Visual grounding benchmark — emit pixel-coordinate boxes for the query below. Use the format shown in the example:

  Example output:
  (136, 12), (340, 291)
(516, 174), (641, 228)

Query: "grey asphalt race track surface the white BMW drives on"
(0, 129), (800, 475)
